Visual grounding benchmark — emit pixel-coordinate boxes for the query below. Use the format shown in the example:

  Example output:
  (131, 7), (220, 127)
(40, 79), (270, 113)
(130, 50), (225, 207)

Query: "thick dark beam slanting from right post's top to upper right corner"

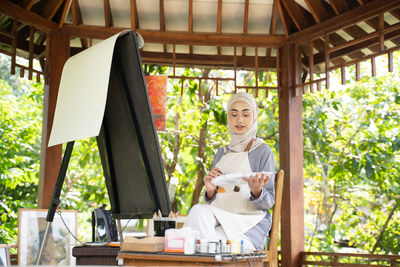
(290, 0), (400, 43)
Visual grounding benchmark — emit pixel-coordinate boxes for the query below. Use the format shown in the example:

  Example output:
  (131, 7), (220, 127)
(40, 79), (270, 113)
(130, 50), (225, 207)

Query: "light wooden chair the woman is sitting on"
(264, 170), (284, 267)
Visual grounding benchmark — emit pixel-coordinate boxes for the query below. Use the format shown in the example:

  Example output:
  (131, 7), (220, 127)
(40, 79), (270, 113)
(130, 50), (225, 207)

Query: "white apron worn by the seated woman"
(210, 152), (265, 244)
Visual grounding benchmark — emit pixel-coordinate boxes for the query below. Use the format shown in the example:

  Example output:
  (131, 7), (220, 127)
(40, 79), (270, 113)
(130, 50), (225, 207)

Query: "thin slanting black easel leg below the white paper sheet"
(35, 141), (75, 265)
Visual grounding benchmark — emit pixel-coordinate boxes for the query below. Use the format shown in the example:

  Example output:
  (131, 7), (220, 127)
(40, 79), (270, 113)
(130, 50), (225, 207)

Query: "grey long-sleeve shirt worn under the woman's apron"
(204, 143), (275, 250)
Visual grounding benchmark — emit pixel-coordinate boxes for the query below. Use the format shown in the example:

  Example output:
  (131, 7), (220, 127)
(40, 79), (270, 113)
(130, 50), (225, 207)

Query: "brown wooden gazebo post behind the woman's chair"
(278, 44), (304, 267)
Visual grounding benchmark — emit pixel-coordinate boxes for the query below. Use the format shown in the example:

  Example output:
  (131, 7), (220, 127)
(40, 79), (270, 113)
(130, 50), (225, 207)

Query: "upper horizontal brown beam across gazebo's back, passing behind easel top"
(63, 24), (287, 47)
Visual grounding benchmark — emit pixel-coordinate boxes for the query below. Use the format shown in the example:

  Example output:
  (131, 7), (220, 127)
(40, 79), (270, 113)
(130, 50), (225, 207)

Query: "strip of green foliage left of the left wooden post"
(0, 72), (43, 243)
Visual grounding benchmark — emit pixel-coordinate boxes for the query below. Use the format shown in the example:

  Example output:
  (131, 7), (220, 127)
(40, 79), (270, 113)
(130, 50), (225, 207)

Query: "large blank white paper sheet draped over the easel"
(49, 31), (143, 146)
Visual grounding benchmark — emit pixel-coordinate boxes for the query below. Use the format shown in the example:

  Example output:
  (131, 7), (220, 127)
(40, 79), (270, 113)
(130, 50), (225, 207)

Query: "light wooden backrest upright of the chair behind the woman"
(267, 170), (284, 253)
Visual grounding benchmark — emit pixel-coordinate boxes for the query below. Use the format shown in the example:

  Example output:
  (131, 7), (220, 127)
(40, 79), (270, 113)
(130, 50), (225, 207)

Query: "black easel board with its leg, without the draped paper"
(36, 31), (171, 265)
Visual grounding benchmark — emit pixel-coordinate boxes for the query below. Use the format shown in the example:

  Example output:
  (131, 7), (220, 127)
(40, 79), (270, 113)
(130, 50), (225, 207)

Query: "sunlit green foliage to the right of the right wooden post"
(303, 53), (400, 254)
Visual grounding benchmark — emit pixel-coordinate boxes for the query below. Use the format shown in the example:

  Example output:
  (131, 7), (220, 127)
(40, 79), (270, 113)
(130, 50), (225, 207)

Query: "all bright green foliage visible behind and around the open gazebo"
(0, 50), (400, 254)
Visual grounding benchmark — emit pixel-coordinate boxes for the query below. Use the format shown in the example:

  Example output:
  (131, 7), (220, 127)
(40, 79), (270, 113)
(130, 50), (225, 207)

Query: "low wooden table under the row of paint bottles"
(118, 251), (266, 267)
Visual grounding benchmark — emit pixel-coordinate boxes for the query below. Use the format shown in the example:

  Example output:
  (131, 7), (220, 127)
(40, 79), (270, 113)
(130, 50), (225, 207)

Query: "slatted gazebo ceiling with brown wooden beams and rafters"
(0, 0), (400, 71)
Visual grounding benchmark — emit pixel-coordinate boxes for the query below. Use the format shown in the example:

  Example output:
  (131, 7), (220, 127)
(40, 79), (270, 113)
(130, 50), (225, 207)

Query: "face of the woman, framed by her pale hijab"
(228, 101), (253, 134)
